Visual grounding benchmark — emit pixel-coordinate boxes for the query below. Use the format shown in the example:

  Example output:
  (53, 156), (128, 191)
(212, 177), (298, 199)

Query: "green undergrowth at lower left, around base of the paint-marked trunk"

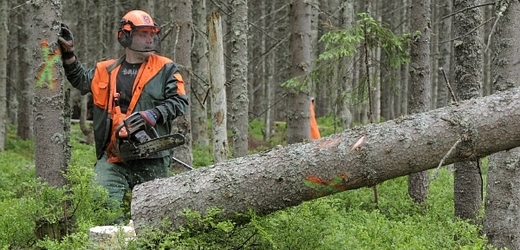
(0, 127), (122, 249)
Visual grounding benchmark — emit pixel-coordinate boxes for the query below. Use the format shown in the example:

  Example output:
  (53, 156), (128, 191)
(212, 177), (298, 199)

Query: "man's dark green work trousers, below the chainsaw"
(94, 153), (171, 209)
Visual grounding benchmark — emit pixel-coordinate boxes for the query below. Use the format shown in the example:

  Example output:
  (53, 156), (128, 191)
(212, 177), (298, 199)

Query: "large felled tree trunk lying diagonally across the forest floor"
(131, 89), (520, 230)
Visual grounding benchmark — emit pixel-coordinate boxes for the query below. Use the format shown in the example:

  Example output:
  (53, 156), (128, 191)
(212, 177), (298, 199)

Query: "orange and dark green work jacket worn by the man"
(64, 54), (188, 159)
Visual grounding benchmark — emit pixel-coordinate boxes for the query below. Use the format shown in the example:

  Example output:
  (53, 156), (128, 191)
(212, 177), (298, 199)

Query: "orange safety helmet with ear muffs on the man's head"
(117, 10), (161, 50)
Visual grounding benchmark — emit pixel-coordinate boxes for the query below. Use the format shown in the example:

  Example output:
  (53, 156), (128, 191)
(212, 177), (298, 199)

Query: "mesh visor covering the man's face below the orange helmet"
(129, 26), (161, 53)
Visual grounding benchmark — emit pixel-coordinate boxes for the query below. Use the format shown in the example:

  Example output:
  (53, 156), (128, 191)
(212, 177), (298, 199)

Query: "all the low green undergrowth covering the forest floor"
(0, 121), (492, 250)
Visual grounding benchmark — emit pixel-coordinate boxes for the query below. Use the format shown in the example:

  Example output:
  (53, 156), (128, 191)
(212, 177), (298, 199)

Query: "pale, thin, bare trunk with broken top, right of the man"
(208, 12), (229, 163)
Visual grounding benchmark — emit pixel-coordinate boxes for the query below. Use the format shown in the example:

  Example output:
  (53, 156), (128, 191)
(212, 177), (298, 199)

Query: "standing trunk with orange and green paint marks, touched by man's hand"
(28, 1), (70, 187)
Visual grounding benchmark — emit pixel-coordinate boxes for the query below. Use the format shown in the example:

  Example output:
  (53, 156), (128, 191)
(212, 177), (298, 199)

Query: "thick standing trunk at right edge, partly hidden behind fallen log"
(484, 1), (520, 249)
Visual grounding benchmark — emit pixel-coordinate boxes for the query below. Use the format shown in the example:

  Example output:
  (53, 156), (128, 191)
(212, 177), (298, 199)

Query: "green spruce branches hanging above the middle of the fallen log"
(308, 13), (411, 111)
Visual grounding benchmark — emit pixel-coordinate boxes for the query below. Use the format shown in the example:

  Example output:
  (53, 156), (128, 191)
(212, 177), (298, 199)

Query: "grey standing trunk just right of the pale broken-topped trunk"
(230, 0), (249, 157)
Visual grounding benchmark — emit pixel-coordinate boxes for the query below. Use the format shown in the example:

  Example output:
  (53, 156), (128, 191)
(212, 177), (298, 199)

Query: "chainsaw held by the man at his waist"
(116, 113), (186, 162)
